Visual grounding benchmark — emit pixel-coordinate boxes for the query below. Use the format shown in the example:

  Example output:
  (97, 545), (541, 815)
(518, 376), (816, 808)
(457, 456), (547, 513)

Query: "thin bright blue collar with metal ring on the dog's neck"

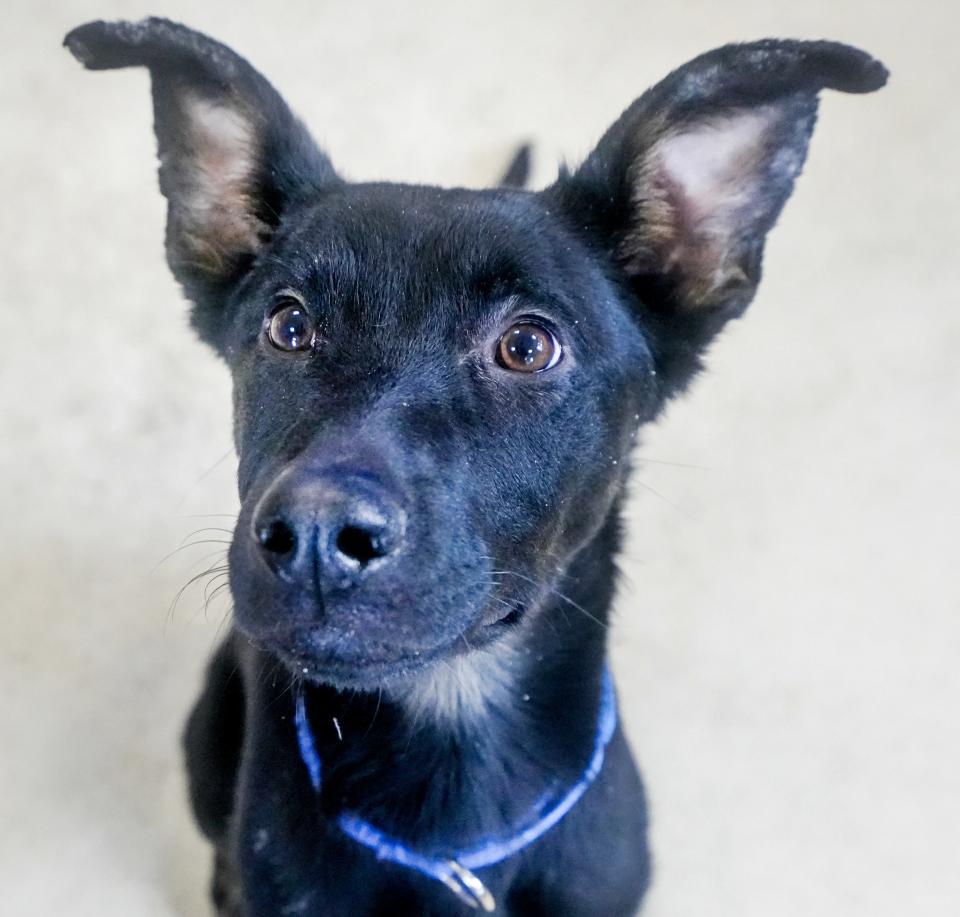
(296, 669), (617, 912)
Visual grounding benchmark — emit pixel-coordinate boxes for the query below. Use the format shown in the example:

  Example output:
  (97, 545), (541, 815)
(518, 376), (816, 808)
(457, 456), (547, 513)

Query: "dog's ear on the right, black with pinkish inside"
(546, 40), (887, 386)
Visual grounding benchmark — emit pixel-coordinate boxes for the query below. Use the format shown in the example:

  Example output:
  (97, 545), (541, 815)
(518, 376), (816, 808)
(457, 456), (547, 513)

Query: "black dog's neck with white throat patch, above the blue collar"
(278, 516), (614, 848)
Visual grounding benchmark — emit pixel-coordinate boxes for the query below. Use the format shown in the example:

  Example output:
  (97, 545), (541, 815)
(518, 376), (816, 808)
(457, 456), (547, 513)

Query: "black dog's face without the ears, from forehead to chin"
(223, 185), (656, 684)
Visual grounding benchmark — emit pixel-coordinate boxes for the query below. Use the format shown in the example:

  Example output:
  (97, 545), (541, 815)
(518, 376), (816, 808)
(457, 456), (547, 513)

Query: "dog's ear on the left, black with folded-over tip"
(64, 19), (338, 340)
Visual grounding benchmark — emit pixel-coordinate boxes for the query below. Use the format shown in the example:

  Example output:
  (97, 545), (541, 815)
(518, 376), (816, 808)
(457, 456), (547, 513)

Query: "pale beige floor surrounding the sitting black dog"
(0, 0), (960, 917)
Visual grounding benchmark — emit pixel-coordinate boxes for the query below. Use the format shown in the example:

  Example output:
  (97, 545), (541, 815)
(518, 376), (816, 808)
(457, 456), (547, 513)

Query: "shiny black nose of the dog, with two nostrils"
(252, 473), (406, 591)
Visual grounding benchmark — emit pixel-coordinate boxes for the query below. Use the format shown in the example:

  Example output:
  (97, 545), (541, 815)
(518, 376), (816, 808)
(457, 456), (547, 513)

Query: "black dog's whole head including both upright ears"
(67, 20), (885, 688)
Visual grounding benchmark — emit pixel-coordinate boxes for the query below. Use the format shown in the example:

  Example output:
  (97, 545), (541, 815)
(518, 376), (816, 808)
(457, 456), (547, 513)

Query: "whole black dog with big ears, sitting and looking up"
(66, 19), (886, 917)
